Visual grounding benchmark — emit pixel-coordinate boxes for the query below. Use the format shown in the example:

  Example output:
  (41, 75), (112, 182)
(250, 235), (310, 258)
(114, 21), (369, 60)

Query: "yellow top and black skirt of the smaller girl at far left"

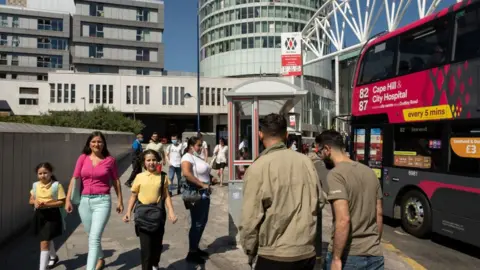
(30, 181), (66, 241)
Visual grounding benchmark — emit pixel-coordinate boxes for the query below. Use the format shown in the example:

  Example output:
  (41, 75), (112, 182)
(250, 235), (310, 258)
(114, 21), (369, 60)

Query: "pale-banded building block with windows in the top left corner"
(0, 5), (70, 80)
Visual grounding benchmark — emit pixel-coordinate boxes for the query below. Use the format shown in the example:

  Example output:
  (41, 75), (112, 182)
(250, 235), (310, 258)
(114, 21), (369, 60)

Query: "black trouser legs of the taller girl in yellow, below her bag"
(138, 228), (165, 270)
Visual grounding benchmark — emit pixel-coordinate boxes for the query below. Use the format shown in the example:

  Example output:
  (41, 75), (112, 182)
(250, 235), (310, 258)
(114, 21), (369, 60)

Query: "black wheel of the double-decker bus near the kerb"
(402, 190), (432, 238)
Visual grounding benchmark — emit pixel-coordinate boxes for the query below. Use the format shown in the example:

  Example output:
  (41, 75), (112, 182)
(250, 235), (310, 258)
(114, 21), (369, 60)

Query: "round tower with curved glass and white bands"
(200, 0), (331, 88)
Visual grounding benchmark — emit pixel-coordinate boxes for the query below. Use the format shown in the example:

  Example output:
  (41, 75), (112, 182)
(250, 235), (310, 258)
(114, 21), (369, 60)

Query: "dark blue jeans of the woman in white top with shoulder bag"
(188, 198), (210, 251)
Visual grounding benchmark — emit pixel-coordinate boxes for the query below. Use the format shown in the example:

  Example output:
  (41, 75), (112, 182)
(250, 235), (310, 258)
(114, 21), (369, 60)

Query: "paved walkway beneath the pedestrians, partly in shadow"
(0, 158), (472, 270)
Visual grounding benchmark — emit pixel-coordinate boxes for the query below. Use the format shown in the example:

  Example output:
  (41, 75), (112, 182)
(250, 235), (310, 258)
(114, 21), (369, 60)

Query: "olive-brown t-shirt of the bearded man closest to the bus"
(327, 161), (383, 256)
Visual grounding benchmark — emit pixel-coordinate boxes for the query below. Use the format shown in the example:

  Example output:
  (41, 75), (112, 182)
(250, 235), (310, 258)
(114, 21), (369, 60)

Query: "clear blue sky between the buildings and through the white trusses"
(0, 0), (456, 72)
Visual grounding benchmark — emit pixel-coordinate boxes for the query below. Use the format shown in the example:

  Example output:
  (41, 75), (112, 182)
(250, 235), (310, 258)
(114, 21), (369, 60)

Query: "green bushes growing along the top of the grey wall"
(0, 105), (145, 134)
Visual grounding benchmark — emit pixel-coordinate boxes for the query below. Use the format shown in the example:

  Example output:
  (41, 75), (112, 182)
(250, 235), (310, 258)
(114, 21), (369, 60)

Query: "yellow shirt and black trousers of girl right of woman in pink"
(131, 171), (170, 270)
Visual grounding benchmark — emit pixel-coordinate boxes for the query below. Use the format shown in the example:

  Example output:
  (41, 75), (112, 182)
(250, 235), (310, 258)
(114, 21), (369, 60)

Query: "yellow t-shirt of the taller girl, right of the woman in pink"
(131, 171), (170, 204)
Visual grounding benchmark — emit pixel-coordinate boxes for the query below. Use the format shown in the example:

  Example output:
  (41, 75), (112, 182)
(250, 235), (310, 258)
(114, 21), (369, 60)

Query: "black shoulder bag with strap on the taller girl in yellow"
(135, 173), (167, 232)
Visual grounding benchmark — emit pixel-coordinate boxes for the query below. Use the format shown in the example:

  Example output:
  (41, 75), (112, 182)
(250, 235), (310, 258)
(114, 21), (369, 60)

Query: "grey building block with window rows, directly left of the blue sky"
(71, 0), (164, 75)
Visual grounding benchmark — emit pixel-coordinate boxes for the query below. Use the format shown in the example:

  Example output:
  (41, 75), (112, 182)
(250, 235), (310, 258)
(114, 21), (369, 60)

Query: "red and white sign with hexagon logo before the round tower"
(280, 32), (303, 76)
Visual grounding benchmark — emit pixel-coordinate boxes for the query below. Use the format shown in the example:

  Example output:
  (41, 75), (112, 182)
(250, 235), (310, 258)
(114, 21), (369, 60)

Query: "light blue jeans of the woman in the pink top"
(78, 195), (112, 270)
